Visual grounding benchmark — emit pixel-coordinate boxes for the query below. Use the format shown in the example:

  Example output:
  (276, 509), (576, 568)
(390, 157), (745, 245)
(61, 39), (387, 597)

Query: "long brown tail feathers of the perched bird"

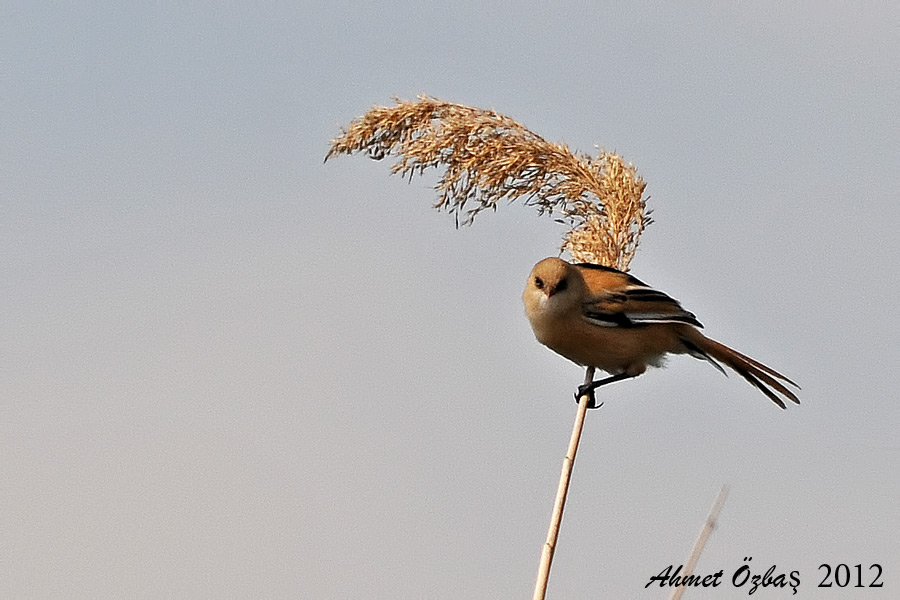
(680, 327), (800, 408)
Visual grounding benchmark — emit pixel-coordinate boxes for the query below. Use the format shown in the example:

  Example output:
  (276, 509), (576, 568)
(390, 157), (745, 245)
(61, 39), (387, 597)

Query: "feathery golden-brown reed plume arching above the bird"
(325, 96), (651, 270)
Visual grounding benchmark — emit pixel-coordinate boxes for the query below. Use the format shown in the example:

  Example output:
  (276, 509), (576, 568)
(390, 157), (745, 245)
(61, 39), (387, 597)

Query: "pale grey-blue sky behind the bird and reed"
(0, 2), (900, 599)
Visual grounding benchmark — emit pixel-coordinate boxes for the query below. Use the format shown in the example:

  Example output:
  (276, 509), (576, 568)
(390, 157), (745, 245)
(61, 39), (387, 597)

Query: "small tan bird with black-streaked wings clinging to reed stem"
(522, 258), (800, 408)
